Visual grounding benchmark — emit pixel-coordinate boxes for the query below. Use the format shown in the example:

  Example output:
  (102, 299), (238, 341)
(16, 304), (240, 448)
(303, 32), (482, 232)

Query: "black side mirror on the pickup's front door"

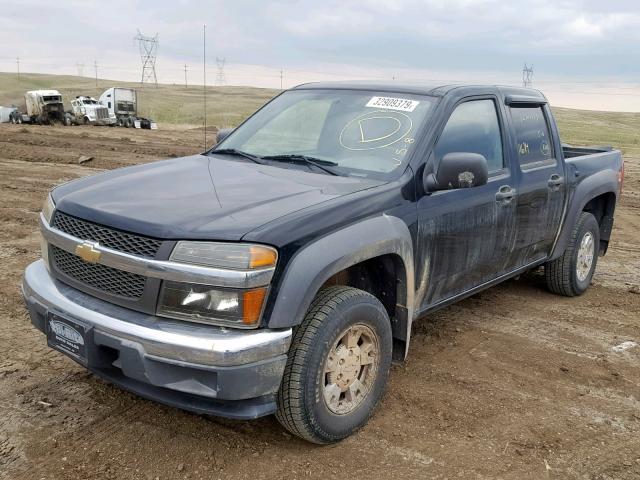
(423, 152), (489, 192)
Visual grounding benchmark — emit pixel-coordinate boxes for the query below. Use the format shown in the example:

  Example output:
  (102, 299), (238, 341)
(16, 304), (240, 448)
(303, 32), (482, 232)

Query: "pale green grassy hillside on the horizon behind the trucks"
(0, 73), (640, 157)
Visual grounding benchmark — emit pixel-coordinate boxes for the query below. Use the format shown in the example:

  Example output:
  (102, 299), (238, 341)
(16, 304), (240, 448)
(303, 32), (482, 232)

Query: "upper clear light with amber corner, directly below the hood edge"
(171, 241), (278, 270)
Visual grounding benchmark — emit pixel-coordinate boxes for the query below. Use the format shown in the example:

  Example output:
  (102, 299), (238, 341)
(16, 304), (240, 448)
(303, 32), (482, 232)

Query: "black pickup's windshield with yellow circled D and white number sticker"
(211, 90), (435, 178)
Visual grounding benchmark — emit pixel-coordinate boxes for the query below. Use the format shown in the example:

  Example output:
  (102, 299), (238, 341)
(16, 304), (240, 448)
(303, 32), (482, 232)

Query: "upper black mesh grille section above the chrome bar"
(52, 211), (162, 258)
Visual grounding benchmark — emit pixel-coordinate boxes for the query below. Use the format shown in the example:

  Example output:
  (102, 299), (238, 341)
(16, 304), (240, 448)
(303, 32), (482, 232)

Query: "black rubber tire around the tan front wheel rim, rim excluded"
(276, 286), (392, 444)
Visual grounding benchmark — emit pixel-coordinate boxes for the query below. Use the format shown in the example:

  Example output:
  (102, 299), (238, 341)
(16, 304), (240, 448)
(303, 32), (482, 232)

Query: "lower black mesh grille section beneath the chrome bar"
(51, 245), (145, 299)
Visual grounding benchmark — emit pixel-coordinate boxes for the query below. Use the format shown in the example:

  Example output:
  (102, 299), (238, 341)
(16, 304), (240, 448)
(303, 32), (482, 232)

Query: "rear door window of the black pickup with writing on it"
(510, 106), (555, 169)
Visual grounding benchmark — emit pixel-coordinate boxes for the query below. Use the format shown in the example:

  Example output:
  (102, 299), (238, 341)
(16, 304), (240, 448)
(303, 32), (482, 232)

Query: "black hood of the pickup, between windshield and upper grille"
(52, 155), (382, 240)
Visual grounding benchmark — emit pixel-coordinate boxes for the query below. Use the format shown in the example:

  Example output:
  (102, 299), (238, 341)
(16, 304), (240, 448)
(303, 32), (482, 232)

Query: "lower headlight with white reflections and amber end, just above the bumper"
(157, 281), (267, 328)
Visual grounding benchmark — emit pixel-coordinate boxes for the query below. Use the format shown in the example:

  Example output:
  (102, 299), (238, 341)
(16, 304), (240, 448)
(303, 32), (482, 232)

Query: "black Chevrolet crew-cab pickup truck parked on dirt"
(23, 83), (623, 443)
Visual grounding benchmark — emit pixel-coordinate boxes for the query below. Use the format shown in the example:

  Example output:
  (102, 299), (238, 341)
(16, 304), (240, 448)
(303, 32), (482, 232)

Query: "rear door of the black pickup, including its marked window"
(507, 104), (566, 266)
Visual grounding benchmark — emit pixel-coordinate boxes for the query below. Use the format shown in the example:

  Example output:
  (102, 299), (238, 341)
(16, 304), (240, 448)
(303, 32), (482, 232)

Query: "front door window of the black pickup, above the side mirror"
(435, 100), (504, 172)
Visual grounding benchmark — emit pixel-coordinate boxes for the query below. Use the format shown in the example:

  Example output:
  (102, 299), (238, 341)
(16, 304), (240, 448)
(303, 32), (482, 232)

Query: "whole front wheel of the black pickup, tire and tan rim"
(276, 286), (392, 444)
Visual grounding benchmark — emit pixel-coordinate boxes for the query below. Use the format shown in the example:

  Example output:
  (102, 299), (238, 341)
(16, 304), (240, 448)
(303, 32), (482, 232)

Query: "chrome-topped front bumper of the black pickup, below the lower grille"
(22, 260), (291, 419)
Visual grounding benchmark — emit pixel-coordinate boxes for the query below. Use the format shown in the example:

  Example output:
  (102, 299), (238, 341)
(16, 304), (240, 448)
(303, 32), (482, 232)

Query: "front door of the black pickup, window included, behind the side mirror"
(418, 97), (516, 311)
